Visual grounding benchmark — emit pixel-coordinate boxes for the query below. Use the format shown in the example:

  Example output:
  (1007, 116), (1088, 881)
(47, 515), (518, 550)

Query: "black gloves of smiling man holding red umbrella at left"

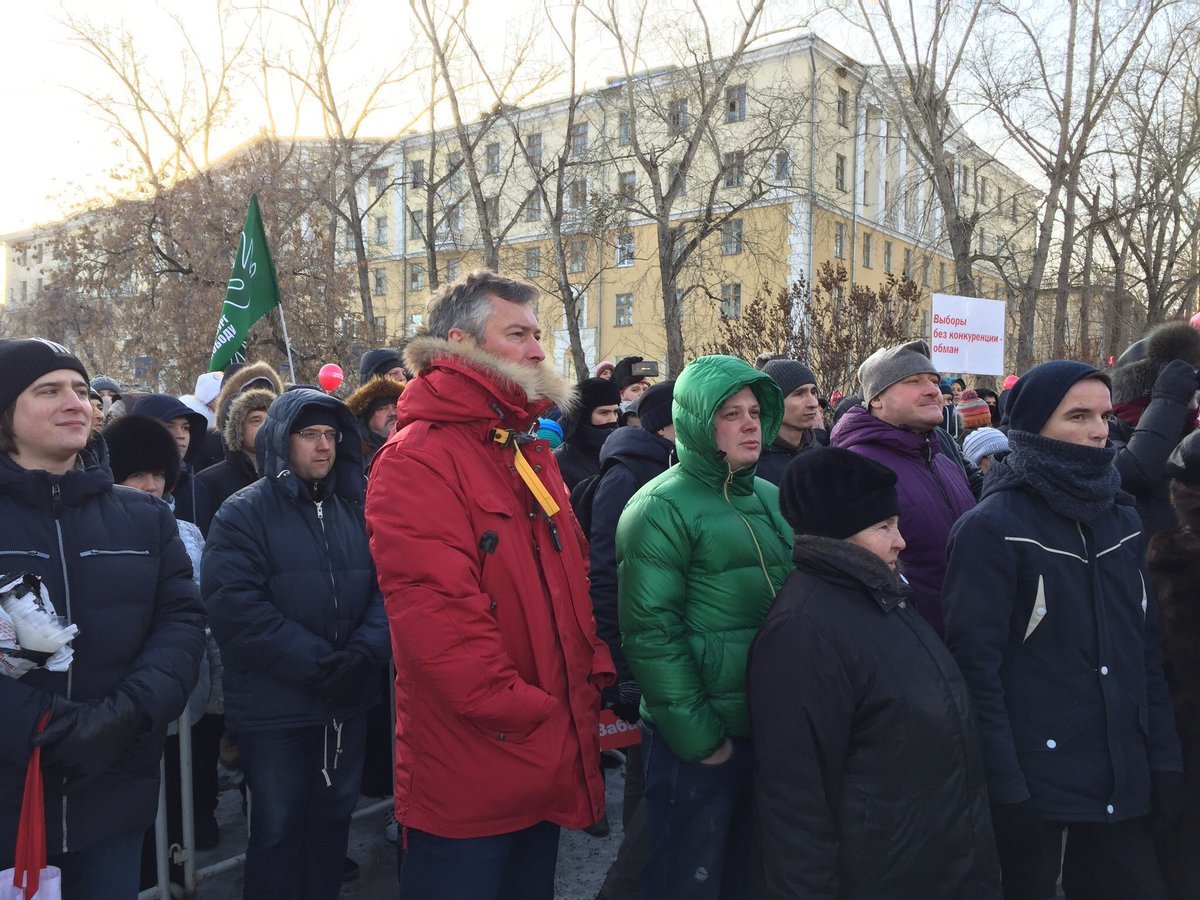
(34, 691), (150, 781)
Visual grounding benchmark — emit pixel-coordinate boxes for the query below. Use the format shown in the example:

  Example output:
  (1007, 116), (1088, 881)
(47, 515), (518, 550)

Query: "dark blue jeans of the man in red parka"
(397, 822), (559, 900)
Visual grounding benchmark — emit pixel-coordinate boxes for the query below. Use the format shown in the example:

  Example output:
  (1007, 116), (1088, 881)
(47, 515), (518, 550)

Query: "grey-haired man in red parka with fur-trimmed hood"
(367, 271), (613, 900)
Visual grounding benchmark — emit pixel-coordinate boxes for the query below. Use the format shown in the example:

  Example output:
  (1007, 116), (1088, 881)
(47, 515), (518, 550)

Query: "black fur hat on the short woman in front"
(779, 446), (900, 540)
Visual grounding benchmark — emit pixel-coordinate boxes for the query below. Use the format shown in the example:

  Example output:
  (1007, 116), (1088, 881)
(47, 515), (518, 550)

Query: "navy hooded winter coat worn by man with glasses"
(200, 390), (390, 731)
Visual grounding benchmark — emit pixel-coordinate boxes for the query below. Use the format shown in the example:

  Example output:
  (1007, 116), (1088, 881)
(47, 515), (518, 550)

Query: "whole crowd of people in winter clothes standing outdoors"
(0, 271), (1200, 900)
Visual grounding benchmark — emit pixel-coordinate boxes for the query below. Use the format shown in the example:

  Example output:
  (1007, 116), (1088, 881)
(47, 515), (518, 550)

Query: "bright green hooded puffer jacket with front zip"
(617, 356), (792, 762)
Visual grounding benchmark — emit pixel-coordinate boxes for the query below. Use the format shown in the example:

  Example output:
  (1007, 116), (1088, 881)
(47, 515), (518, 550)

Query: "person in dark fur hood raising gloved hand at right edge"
(1109, 322), (1200, 535)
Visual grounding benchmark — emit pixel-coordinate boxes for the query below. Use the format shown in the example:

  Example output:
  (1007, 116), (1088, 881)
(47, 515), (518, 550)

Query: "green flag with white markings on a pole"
(209, 194), (280, 372)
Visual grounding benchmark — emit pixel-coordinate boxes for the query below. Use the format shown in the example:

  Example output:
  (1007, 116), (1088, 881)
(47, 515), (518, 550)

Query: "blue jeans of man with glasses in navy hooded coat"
(238, 715), (366, 900)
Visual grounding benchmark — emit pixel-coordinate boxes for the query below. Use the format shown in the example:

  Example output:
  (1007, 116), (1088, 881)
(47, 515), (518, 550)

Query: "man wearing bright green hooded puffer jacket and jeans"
(617, 356), (792, 900)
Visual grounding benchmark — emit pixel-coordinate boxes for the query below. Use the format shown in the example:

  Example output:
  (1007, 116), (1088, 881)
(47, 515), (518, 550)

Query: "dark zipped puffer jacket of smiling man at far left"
(0, 448), (204, 868)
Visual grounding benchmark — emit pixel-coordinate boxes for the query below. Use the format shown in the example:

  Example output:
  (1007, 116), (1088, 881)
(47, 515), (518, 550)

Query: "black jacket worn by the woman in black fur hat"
(748, 536), (1001, 900)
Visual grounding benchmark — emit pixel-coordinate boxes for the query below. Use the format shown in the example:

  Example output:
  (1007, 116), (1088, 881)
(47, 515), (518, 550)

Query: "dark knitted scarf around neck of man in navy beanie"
(1003, 431), (1121, 522)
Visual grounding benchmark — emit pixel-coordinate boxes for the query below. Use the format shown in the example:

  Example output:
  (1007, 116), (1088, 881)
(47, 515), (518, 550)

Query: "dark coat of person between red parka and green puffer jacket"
(588, 426), (674, 682)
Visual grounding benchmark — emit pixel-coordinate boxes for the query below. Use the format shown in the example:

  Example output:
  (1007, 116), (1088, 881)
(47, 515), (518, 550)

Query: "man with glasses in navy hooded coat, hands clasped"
(200, 390), (389, 900)
